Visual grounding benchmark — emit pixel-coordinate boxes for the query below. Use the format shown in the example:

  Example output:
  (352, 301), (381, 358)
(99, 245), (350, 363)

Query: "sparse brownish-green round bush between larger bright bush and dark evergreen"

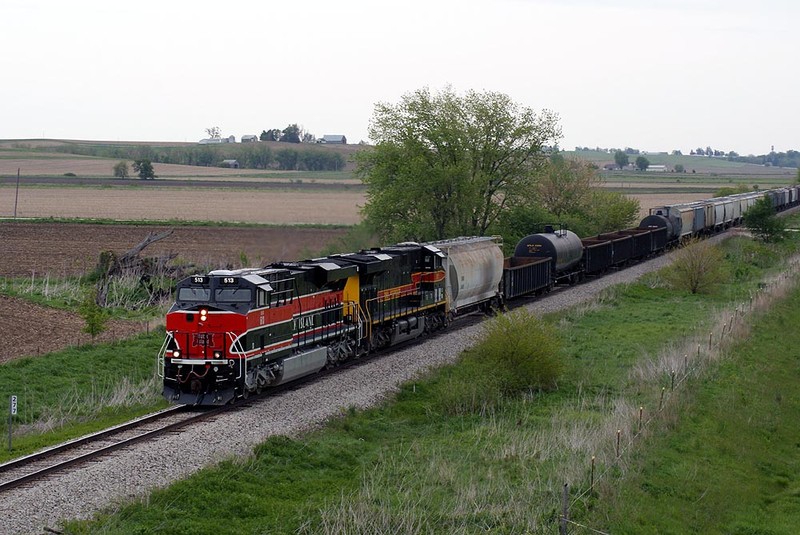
(667, 239), (726, 294)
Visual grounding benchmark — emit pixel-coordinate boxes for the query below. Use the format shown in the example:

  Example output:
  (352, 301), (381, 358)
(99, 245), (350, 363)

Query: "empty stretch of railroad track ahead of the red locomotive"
(0, 406), (220, 493)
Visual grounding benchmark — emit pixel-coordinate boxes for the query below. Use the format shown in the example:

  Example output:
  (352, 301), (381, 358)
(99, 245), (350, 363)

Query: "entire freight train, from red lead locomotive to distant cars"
(158, 186), (800, 405)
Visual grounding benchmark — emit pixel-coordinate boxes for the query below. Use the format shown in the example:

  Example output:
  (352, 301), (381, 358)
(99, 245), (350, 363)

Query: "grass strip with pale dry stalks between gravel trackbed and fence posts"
(51, 220), (799, 533)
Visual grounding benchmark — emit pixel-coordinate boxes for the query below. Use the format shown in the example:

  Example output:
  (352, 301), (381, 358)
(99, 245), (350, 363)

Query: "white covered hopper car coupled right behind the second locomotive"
(428, 236), (503, 314)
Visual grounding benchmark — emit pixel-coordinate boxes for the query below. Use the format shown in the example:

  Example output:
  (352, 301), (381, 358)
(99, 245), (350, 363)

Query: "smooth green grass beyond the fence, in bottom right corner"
(586, 290), (800, 535)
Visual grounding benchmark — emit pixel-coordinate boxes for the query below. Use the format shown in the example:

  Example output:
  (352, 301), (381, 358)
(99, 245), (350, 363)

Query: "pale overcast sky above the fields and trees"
(0, 0), (800, 154)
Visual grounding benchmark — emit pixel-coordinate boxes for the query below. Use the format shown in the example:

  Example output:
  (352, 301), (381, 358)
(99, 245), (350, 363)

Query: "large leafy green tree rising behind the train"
(356, 87), (561, 240)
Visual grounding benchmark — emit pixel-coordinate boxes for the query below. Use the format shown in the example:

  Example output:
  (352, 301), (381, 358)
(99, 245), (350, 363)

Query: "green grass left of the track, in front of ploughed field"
(0, 331), (166, 461)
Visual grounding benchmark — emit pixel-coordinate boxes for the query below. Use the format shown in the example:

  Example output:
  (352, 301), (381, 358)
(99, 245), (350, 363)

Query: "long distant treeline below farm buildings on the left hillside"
(47, 143), (347, 171)
